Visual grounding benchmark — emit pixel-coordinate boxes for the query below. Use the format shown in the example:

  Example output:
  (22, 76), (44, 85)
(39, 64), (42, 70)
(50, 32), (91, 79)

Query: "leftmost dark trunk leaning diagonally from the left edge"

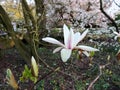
(0, 5), (31, 64)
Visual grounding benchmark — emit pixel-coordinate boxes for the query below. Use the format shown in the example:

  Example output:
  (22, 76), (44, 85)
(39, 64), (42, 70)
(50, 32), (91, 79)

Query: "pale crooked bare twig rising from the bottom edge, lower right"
(87, 63), (110, 90)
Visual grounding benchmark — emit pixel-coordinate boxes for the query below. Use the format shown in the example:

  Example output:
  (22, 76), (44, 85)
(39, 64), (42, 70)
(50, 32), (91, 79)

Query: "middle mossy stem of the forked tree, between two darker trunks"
(21, 0), (39, 61)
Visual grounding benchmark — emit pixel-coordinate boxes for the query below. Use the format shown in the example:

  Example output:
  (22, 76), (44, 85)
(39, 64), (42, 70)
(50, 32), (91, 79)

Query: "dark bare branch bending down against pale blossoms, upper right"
(100, 0), (119, 33)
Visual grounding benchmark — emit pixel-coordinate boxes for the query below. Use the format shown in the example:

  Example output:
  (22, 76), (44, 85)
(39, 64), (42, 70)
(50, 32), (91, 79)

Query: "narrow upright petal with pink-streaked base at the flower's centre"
(66, 28), (74, 49)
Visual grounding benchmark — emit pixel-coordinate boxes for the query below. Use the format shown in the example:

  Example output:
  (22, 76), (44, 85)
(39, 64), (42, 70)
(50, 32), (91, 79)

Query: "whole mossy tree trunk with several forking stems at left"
(0, 0), (46, 65)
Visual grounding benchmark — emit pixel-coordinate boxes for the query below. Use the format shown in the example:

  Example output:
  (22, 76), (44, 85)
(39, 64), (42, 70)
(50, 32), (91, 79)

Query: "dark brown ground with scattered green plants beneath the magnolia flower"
(0, 40), (120, 90)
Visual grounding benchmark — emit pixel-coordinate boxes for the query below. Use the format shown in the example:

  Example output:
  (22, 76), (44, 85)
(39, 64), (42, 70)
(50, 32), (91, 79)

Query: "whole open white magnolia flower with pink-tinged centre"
(42, 24), (99, 62)
